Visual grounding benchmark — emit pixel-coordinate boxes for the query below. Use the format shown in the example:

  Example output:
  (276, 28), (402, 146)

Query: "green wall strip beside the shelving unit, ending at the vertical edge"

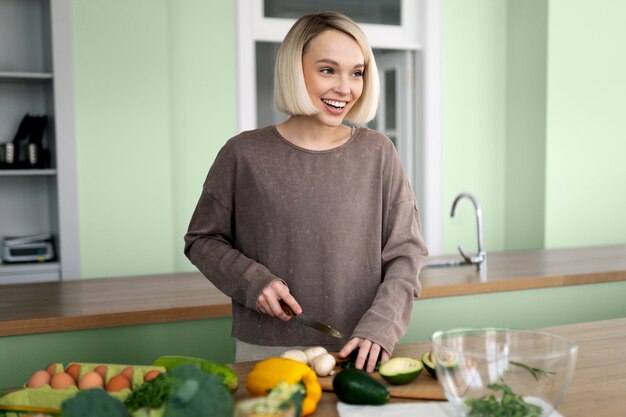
(72, 0), (175, 278)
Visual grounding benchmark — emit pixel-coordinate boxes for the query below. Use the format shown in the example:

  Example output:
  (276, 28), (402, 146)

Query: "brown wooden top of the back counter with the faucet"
(0, 245), (626, 336)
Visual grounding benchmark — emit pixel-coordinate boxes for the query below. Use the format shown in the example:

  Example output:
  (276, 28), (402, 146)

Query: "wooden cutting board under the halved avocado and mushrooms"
(317, 367), (446, 401)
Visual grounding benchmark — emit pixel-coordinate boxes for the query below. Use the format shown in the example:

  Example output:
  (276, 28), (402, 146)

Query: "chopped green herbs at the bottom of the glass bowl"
(465, 384), (542, 417)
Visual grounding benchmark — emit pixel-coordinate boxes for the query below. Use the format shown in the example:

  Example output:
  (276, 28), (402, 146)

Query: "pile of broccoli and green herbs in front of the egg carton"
(61, 363), (233, 417)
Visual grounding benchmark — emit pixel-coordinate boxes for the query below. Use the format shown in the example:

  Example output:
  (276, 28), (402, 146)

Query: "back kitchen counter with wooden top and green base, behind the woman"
(0, 246), (626, 387)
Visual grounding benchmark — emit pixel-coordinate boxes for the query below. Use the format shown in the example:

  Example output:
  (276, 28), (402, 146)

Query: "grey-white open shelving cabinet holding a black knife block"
(0, 0), (79, 284)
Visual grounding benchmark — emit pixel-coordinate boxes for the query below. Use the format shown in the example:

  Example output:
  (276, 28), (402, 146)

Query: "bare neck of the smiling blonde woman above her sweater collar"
(276, 116), (352, 151)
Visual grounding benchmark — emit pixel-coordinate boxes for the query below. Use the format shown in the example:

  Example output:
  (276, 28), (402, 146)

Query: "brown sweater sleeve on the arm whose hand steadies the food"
(352, 148), (428, 355)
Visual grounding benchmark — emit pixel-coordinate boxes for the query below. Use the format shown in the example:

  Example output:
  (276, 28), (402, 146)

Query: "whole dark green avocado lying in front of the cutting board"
(333, 368), (389, 405)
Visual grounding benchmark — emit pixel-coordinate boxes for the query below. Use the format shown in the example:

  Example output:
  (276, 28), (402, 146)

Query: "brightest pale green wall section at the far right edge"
(546, 0), (626, 247)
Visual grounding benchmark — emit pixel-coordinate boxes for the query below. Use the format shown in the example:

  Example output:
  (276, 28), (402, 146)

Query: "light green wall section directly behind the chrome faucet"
(438, 0), (506, 253)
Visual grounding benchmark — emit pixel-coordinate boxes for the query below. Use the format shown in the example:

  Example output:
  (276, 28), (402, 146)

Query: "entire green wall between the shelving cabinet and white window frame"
(72, 0), (236, 278)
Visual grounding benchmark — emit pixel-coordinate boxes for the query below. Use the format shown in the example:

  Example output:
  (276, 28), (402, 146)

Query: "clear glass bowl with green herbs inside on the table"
(431, 328), (578, 417)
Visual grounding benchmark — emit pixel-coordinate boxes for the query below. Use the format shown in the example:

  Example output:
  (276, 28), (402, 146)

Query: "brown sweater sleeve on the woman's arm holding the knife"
(184, 146), (280, 310)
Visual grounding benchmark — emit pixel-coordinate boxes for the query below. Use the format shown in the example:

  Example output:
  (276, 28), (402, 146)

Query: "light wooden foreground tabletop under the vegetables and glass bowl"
(232, 318), (626, 417)
